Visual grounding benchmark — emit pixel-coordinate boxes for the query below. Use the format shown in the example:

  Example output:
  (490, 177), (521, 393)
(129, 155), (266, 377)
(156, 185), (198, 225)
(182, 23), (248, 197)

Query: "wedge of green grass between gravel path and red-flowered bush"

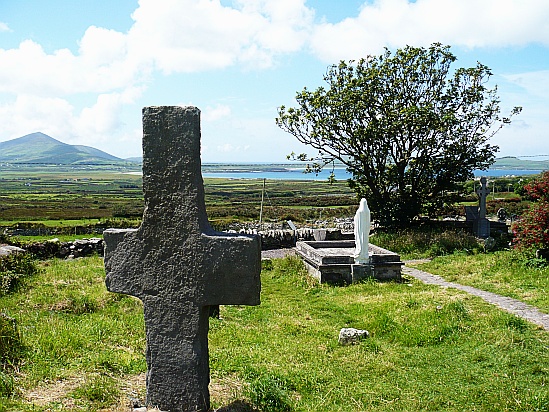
(415, 251), (549, 313)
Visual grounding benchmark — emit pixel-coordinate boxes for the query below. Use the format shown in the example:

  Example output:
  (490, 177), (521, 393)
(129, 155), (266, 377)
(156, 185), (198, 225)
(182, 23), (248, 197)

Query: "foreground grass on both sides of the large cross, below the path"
(0, 257), (549, 412)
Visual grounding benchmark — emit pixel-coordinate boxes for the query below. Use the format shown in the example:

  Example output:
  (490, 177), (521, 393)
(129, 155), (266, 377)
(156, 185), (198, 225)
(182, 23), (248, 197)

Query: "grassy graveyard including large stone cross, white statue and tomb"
(0, 107), (549, 412)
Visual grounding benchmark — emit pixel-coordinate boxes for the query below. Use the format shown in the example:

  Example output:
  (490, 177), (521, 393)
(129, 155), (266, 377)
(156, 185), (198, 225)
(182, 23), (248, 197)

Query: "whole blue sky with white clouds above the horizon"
(0, 0), (549, 162)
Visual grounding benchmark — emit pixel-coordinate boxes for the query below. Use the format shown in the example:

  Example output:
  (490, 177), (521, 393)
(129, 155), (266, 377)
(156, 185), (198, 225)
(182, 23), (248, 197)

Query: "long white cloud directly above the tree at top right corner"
(311, 0), (549, 63)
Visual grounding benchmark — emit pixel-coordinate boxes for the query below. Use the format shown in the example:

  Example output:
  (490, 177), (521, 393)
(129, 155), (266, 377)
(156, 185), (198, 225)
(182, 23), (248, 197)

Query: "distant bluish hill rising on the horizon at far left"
(0, 132), (135, 165)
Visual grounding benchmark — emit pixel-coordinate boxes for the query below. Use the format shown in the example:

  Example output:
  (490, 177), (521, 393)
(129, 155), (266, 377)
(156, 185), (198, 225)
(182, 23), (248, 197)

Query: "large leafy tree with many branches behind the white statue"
(276, 43), (520, 227)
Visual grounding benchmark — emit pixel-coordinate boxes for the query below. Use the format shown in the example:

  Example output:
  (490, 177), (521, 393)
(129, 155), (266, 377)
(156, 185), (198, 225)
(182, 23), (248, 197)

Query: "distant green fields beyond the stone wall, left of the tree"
(0, 167), (357, 229)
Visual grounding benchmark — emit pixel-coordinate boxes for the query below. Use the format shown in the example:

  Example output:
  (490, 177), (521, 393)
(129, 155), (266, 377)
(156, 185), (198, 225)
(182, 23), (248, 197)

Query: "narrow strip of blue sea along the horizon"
(202, 168), (543, 181)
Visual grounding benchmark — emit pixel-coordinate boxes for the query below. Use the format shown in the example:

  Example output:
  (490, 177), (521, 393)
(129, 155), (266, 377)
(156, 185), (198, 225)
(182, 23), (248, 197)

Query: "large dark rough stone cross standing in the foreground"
(104, 106), (261, 412)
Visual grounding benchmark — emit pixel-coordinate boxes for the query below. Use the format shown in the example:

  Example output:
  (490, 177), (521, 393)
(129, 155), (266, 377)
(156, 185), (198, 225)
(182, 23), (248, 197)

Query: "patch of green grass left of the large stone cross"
(0, 257), (146, 411)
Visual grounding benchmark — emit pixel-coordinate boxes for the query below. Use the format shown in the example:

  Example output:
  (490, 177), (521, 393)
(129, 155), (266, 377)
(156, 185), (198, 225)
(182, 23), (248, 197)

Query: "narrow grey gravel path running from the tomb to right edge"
(402, 266), (549, 330)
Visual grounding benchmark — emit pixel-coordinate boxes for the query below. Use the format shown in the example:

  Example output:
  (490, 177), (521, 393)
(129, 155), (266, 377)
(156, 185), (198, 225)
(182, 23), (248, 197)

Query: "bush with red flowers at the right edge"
(513, 172), (549, 249)
